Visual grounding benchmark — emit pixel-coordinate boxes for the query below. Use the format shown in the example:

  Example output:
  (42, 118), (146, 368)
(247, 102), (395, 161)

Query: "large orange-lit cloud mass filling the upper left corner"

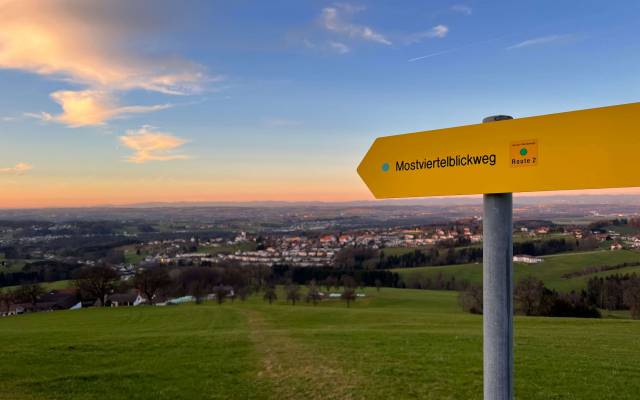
(0, 0), (212, 126)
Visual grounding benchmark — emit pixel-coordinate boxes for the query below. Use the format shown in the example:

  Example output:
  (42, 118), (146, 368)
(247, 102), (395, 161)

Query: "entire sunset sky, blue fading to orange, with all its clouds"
(0, 0), (640, 208)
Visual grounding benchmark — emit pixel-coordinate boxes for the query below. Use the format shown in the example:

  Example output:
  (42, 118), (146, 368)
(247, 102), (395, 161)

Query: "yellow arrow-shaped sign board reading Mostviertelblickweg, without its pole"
(358, 103), (640, 198)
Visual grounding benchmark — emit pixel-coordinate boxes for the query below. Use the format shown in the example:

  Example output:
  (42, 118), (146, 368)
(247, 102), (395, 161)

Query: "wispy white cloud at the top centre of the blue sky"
(321, 3), (391, 45)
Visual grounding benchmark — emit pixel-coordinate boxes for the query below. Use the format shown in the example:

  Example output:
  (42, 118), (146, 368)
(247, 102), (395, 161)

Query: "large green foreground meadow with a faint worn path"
(0, 288), (640, 400)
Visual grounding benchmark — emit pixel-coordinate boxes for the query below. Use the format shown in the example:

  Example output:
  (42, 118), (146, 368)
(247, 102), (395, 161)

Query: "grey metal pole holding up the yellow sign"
(482, 115), (513, 400)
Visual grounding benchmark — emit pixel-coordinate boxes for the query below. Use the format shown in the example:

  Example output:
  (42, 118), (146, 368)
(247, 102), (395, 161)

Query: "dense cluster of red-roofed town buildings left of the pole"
(136, 224), (482, 267)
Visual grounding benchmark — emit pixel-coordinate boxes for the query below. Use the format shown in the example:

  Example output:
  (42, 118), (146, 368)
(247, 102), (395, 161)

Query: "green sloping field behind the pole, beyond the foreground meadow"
(393, 250), (640, 291)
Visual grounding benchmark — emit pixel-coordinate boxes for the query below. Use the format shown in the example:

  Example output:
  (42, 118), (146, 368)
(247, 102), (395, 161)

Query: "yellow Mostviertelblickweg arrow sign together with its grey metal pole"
(358, 103), (640, 400)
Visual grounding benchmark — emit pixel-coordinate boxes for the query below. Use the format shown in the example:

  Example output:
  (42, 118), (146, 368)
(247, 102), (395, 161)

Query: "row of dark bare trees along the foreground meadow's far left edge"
(0, 264), (376, 310)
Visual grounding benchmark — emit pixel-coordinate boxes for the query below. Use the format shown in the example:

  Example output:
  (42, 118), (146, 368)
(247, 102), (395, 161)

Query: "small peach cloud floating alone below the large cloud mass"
(119, 126), (189, 164)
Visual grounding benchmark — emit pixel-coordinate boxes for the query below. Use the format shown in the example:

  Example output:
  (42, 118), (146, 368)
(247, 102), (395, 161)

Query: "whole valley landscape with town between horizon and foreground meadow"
(0, 204), (640, 314)
